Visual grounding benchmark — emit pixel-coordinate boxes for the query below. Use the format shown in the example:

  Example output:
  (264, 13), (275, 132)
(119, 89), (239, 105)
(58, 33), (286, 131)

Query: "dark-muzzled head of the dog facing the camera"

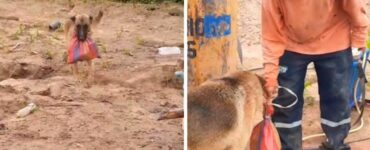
(70, 14), (93, 41)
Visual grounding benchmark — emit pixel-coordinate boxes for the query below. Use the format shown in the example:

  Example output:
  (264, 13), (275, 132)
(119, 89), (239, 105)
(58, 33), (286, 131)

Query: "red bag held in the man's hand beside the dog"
(250, 104), (281, 150)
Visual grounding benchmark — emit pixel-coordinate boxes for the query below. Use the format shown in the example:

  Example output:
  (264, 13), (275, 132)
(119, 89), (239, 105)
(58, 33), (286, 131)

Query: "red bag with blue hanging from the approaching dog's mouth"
(67, 36), (100, 64)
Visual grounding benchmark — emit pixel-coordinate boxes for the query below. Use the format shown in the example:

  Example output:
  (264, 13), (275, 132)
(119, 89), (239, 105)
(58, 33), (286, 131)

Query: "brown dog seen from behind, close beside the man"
(188, 71), (264, 150)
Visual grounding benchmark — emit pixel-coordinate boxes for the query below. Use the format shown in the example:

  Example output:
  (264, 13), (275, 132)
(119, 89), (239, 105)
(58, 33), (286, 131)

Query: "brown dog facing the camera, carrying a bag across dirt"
(64, 11), (103, 83)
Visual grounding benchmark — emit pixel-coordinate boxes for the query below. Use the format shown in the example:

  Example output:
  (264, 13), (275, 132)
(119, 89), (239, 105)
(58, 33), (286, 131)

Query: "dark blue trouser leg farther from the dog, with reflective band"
(314, 49), (353, 149)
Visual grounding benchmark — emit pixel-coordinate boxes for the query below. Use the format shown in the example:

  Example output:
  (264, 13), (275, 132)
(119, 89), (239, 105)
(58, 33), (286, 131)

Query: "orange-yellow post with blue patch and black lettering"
(187, 0), (240, 87)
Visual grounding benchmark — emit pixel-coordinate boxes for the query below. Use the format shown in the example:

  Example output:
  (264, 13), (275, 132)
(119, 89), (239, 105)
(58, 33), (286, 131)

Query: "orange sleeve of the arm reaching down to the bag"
(262, 0), (286, 87)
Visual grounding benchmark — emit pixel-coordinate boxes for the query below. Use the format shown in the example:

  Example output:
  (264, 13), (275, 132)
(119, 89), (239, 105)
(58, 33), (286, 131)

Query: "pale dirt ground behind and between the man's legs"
(238, 0), (370, 150)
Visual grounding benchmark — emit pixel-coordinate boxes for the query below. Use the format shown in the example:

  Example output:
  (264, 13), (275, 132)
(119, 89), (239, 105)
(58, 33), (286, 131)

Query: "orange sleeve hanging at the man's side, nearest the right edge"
(342, 0), (369, 48)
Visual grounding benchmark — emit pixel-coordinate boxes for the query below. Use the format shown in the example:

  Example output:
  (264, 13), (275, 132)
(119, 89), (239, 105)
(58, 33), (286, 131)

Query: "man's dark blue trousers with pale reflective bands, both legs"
(272, 49), (353, 150)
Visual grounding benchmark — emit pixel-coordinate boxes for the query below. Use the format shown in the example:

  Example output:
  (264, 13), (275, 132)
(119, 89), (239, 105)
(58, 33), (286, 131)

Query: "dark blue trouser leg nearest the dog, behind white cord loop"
(272, 51), (311, 150)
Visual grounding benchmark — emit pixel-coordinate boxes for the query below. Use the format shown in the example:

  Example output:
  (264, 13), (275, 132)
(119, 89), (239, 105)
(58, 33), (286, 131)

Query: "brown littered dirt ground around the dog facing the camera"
(0, 0), (183, 150)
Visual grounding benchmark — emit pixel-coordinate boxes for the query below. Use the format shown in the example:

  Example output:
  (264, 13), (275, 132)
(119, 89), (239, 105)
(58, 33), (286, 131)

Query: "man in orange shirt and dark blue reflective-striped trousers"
(262, 0), (368, 150)
